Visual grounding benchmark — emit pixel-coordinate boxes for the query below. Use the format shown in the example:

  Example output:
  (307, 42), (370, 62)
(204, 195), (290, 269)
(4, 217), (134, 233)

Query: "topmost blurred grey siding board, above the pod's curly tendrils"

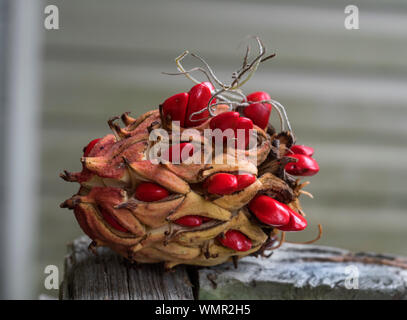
(47, 0), (407, 70)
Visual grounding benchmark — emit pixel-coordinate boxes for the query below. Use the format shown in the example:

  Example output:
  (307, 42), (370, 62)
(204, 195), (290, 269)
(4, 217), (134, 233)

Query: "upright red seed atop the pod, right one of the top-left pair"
(184, 82), (216, 128)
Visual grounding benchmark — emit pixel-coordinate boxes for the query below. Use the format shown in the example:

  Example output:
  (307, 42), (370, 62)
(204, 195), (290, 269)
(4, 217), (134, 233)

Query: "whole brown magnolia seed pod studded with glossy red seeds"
(60, 43), (322, 269)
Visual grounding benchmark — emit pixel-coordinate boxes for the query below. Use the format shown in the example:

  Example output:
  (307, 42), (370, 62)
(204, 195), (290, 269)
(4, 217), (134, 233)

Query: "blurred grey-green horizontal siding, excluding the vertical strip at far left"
(41, 0), (407, 296)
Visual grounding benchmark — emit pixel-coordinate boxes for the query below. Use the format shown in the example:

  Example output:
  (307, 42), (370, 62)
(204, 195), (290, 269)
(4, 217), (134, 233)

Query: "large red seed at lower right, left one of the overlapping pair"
(249, 195), (291, 226)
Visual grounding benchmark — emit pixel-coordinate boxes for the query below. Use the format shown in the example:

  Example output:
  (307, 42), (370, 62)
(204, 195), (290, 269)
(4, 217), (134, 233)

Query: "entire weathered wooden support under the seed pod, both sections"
(60, 237), (407, 300)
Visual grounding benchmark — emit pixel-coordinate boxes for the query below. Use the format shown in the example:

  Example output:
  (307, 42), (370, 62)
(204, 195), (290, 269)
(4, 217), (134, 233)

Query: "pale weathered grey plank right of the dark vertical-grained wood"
(199, 244), (407, 300)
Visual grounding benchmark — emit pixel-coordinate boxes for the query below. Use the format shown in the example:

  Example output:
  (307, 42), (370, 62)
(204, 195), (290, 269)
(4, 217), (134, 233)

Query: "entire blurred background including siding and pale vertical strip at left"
(0, 0), (407, 299)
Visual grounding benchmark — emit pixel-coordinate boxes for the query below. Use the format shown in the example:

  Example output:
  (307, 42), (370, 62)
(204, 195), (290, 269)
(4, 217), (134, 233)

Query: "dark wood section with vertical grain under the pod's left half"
(60, 236), (193, 300)
